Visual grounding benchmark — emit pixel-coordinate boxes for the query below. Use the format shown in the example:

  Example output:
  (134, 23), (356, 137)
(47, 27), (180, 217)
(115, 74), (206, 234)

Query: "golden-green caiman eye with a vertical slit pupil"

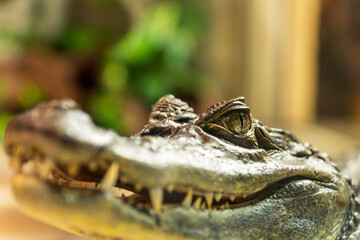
(215, 110), (251, 134)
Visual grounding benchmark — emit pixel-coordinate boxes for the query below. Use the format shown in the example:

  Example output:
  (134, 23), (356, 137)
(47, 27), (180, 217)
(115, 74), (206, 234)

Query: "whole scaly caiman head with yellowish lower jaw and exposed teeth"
(4, 95), (359, 240)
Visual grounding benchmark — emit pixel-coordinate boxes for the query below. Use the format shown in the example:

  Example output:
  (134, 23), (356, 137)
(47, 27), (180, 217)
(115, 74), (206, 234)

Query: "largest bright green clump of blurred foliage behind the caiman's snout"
(90, 1), (205, 133)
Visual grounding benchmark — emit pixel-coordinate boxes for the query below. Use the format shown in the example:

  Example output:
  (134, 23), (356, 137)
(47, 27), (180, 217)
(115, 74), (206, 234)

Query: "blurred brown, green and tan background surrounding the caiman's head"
(0, 0), (360, 239)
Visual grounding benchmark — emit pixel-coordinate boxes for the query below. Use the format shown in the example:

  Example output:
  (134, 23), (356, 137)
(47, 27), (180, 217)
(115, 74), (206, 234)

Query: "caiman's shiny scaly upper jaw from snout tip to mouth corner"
(4, 101), (344, 214)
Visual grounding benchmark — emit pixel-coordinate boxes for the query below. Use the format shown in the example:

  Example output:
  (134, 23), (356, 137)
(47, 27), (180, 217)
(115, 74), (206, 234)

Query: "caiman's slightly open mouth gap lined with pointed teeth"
(10, 146), (310, 214)
